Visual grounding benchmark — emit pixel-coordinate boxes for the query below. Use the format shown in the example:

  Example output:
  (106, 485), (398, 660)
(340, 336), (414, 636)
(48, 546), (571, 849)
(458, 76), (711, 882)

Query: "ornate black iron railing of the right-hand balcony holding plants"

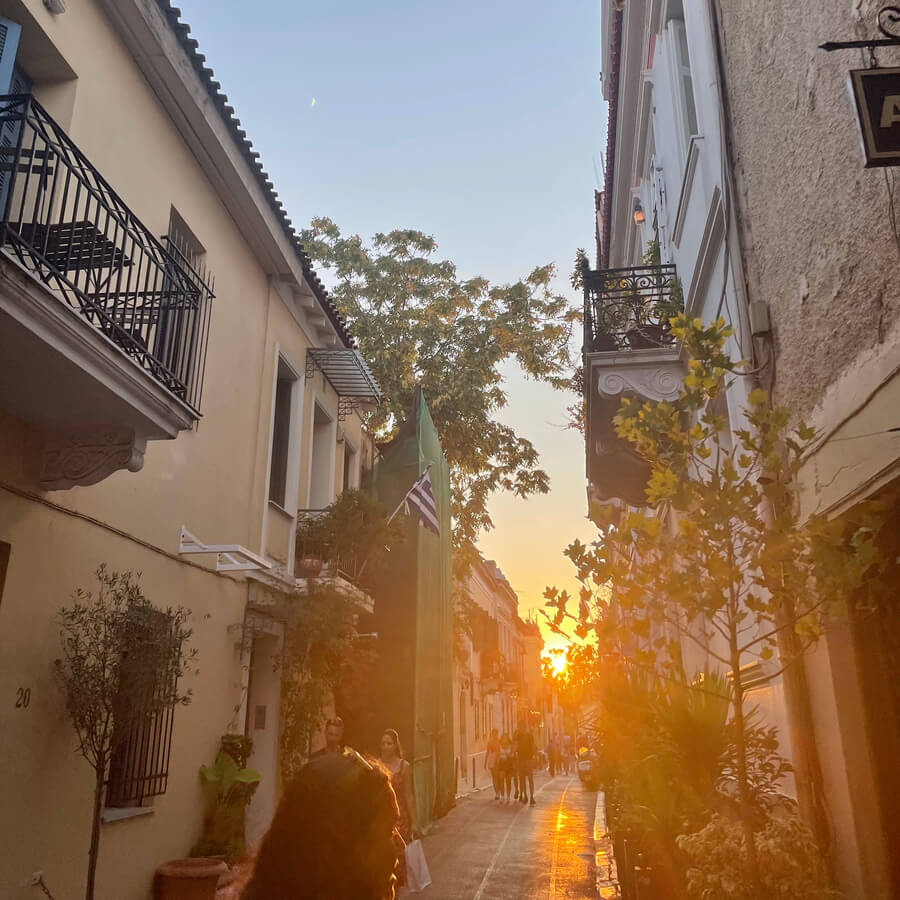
(582, 265), (684, 353)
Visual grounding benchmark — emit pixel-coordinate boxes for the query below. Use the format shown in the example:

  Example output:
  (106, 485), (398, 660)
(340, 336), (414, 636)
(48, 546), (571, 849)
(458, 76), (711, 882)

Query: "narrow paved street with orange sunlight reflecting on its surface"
(402, 774), (597, 900)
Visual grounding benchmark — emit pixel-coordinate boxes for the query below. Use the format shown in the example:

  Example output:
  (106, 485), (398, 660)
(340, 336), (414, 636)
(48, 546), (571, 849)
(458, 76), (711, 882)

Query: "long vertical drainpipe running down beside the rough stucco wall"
(707, 0), (834, 884)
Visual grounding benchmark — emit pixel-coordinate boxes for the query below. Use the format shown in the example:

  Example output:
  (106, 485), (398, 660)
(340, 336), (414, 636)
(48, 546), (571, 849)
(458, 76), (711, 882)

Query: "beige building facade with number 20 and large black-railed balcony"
(0, 0), (379, 900)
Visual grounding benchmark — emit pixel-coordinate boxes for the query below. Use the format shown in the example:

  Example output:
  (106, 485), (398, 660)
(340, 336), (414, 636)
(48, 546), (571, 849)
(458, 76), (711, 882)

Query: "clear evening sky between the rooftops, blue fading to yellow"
(179, 0), (606, 652)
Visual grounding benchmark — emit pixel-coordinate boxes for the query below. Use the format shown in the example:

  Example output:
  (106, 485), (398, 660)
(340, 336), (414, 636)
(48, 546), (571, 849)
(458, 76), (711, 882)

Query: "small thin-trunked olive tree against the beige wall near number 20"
(55, 565), (196, 900)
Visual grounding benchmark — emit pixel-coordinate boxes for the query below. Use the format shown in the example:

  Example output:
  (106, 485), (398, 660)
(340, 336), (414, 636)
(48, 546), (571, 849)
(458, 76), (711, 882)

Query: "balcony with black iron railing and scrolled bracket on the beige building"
(0, 95), (213, 490)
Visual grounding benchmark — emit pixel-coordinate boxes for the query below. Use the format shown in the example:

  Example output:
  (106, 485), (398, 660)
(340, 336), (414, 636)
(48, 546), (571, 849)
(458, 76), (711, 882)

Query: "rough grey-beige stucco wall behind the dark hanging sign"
(718, 0), (900, 415)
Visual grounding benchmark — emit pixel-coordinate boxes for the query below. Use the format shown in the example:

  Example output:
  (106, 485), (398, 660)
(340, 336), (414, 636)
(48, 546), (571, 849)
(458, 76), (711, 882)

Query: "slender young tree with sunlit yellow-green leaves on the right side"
(546, 315), (880, 896)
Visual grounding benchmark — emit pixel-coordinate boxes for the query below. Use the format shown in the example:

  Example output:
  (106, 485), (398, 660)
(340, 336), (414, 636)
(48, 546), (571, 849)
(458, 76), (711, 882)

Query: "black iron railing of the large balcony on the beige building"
(0, 94), (214, 415)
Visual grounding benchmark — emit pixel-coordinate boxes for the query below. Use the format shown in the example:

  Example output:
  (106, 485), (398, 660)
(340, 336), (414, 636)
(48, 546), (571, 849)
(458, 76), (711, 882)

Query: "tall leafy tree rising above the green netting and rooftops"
(301, 218), (581, 561)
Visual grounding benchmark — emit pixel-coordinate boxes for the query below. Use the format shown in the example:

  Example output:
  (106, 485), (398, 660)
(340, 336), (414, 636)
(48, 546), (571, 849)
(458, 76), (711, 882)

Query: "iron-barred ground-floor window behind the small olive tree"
(104, 609), (181, 807)
